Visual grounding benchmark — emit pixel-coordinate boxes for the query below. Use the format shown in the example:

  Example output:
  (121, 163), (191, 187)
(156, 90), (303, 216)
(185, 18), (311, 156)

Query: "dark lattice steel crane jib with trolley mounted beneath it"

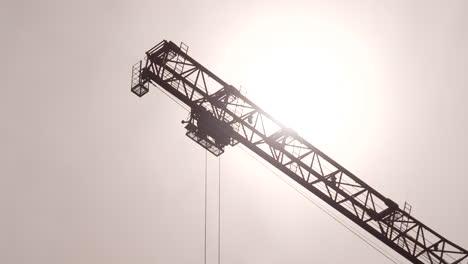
(131, 41), (468, 264)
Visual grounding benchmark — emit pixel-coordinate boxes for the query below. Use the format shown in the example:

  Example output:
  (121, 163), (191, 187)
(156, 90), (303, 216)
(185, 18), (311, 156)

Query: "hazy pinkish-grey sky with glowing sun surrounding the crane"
(0, 0), (468, 264)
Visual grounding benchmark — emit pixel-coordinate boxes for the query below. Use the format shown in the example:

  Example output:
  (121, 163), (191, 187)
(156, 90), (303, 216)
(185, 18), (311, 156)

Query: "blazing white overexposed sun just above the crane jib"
(238, 19), (376, 145)
